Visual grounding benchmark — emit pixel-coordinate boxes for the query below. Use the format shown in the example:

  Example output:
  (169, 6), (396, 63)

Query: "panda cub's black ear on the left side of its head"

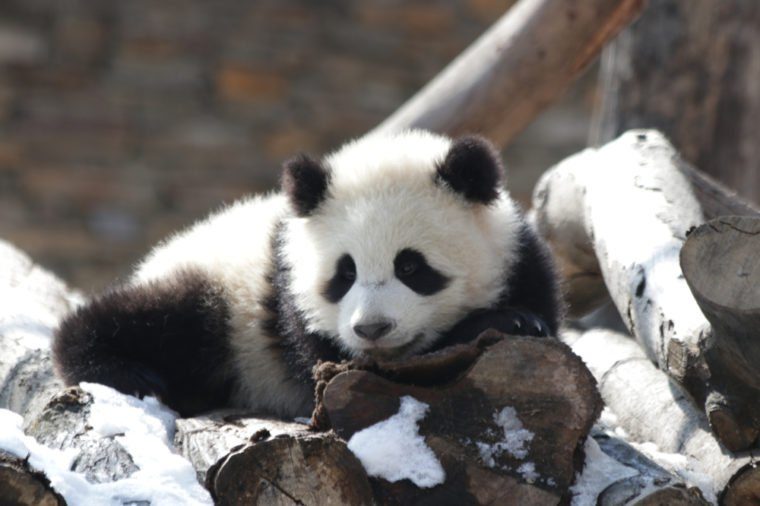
(280, 154), (330, 217)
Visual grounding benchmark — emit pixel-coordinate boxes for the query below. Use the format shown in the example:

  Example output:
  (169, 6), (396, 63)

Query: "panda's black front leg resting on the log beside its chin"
(441, 307), (550, 346)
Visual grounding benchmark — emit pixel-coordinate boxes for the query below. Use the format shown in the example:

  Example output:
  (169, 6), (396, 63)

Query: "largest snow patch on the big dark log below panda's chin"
(348, 395), (446, 488)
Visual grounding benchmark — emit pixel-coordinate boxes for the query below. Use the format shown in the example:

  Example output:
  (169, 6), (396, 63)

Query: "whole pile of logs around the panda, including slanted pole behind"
(0, 0), (760, 505)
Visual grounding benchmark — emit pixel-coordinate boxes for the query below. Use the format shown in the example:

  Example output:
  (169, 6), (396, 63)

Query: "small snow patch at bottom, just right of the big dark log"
(570, 436), (639, 506)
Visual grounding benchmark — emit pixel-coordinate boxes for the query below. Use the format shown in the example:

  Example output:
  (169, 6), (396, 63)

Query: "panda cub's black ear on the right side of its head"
(436, 135), (504, 204)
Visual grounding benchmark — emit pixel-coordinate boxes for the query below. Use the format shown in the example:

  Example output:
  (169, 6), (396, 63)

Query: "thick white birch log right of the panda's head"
(533, 131), (709, 362)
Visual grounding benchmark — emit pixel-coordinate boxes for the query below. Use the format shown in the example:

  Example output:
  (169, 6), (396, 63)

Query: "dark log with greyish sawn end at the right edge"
(681, 216), (760, 450)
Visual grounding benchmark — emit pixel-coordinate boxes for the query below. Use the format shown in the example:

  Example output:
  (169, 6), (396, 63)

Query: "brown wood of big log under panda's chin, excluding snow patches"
(324, 331), (601, 504)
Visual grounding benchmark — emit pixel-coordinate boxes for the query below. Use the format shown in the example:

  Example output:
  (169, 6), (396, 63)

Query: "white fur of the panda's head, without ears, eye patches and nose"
(284, 131), (520, 355)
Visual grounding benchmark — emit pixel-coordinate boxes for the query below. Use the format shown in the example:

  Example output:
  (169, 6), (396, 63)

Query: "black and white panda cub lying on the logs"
(53, 131), (561, 417)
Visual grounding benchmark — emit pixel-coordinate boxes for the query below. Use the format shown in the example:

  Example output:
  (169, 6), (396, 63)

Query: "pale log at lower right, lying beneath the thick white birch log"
(562, 329), (760, 506)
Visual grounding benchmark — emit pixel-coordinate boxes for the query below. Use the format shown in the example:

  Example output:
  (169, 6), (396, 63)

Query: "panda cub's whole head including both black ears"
(281, 131), (520, 356)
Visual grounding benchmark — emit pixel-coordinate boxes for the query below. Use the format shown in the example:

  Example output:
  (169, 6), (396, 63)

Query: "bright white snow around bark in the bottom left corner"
(0, 383), (213, 506)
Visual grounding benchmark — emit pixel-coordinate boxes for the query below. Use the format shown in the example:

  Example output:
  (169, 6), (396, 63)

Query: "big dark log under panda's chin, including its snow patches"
(322, 331), (601, 505)
